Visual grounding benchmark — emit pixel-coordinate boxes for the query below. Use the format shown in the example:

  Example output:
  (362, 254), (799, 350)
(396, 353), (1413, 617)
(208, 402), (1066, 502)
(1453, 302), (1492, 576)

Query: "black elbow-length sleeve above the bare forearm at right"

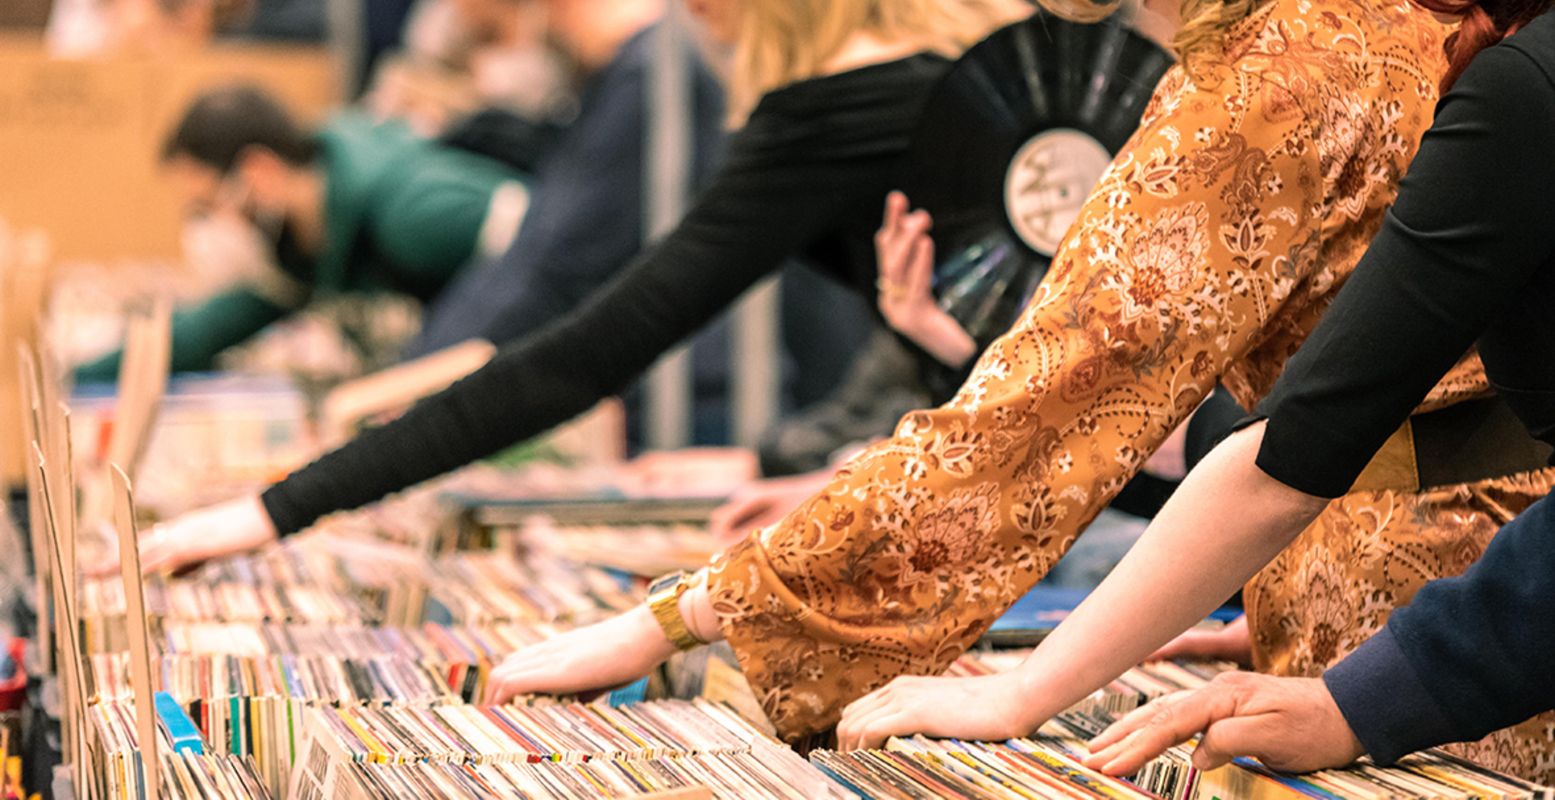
(1258, 45), (1555, 496)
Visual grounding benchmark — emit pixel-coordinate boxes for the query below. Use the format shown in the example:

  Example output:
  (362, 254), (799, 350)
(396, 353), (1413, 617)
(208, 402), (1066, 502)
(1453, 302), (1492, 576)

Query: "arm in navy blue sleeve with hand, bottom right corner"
(1087, 485), (1555, 775)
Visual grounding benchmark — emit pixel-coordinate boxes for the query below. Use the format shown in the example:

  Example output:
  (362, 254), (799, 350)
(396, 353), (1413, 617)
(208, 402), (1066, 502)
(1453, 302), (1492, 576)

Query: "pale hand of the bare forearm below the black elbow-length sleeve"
(837, 672), (1036, 750)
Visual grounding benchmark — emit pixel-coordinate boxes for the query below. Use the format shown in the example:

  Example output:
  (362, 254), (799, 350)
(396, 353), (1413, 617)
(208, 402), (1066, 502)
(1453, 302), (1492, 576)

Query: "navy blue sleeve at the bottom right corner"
(1323, 496), (1555, 764)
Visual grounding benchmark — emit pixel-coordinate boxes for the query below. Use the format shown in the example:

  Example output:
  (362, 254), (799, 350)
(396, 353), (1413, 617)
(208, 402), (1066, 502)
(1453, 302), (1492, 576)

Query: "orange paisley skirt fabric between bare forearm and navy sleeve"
(1244, 470), (1555, 784)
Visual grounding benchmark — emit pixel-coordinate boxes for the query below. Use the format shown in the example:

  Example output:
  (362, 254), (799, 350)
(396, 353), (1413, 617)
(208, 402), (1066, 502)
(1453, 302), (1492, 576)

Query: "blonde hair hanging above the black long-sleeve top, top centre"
(728, 0), (1033, 125)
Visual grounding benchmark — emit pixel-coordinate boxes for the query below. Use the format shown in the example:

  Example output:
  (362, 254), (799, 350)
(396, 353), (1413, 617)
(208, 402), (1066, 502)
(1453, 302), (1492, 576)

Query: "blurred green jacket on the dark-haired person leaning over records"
(76, 112), (521, 381)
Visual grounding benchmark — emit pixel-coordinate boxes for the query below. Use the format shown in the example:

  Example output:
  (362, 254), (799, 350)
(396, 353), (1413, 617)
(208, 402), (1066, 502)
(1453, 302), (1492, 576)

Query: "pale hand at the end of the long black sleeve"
(87, 495), (278, 576)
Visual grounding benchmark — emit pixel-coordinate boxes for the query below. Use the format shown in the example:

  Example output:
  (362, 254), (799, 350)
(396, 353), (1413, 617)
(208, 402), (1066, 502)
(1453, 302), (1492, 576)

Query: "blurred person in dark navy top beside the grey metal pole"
(394, 0), (725, 358)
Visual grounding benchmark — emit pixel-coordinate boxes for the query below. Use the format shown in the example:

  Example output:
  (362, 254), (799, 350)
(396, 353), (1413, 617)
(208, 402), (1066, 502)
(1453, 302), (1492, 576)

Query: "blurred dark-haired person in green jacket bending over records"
(76, 86), (527, 381)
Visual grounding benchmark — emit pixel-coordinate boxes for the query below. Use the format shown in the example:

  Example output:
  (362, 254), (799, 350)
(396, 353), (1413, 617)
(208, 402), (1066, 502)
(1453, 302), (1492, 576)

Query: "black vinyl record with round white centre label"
(905, 12), (1172, 347)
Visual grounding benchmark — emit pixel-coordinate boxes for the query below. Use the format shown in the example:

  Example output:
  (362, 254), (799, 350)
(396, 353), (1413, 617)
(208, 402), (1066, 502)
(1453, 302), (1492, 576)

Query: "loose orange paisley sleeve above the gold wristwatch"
(709, 0), (1455, 738)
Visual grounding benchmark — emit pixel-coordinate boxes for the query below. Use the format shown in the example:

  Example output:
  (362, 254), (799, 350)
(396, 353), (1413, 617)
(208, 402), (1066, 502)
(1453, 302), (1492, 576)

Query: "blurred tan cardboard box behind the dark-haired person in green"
(0, 34), (341, 261)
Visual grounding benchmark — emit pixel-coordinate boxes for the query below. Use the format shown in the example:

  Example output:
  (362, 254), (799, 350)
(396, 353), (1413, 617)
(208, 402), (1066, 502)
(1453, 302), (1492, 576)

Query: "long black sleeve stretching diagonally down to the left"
(263, 54), (949, 532)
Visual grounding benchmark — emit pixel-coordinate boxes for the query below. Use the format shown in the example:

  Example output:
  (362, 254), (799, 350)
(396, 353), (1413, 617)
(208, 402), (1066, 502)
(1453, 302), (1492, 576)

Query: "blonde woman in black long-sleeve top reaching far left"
(118, 0), (1031, 570)
